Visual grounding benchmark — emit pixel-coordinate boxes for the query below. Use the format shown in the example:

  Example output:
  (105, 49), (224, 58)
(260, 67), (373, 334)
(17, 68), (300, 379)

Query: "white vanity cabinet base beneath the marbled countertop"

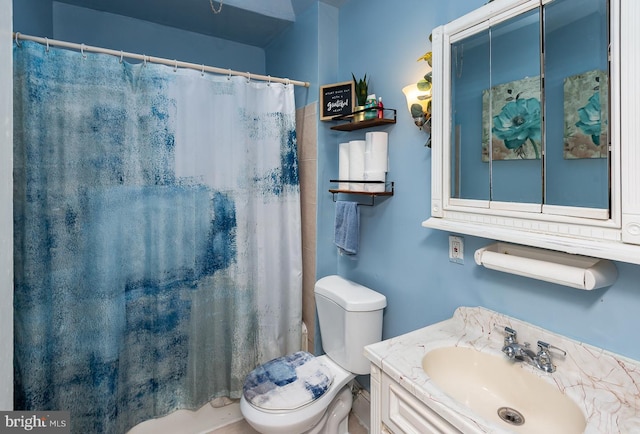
(370, 365), (462, 434)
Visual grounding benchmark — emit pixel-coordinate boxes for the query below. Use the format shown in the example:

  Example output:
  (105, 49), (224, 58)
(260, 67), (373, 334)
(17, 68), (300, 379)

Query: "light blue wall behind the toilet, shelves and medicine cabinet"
(324, 0), (640, 359)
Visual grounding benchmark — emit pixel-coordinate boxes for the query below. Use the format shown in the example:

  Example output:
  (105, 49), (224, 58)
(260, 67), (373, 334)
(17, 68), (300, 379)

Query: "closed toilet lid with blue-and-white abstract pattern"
(242, 351), (333, 410)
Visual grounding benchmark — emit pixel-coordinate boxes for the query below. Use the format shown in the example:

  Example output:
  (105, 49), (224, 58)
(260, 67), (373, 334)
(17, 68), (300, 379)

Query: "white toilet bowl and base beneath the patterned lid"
(240, 355), (355, 434)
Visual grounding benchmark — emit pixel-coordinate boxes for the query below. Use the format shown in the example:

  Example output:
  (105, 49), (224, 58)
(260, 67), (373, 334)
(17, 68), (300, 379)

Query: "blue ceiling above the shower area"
(57, 0), (347, 48)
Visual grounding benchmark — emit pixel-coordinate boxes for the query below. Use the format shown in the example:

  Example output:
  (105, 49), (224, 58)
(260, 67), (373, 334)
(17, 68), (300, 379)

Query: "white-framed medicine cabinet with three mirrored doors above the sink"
(423, 0), (640, 264)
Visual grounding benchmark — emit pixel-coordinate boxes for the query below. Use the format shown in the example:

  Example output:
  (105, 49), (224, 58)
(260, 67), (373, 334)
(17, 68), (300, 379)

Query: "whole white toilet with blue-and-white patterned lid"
(240, 276), (387, 434)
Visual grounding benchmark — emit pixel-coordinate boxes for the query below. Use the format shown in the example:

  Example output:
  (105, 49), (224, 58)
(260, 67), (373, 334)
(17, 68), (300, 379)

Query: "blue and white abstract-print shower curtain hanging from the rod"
(14, 42), (302, 434)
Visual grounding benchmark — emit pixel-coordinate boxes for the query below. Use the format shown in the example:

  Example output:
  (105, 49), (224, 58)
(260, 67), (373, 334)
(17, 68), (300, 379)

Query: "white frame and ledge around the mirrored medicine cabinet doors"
(422, 0), (640, 264)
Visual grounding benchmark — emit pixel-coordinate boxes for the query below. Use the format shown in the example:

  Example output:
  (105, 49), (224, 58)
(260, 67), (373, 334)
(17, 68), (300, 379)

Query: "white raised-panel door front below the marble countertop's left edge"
(380, 373), (461, 434)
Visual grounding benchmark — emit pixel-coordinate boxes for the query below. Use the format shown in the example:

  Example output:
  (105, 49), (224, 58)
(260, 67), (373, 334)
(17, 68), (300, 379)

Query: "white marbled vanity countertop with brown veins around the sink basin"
(365, 307), (640, 434)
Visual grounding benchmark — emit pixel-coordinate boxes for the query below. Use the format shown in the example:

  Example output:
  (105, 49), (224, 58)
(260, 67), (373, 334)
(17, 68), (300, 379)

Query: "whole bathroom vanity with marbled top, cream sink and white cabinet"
(364, 307), (640, 434)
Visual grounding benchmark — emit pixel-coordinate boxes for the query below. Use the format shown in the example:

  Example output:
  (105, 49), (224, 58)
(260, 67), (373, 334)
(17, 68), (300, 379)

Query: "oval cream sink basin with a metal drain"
(422, 347), (586, 434)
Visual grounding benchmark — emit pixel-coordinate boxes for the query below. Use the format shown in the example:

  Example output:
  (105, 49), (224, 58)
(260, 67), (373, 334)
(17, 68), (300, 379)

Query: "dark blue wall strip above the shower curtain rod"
(13, 0), (266, 74)
